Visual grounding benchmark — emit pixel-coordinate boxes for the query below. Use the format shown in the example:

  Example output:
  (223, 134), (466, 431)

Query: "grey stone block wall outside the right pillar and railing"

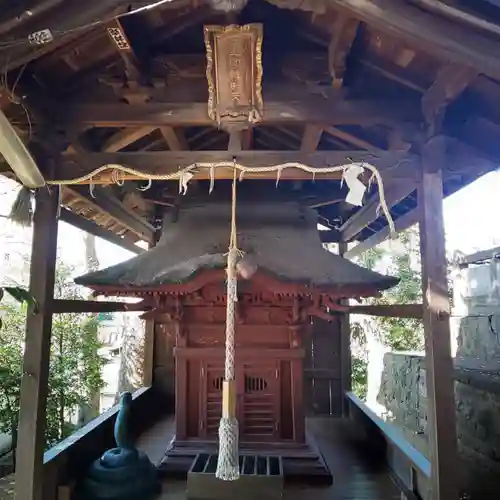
(378, 262), (500, 498)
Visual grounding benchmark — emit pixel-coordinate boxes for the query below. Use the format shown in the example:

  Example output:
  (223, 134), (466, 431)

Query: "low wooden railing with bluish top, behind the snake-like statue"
(43, 387), (173, 500)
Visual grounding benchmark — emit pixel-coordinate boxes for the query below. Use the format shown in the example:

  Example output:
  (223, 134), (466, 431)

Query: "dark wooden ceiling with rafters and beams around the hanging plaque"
(0, 0), (500, 254)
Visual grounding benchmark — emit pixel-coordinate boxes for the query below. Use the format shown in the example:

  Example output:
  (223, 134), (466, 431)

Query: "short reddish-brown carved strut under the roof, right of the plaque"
(328, 12), (359, 90)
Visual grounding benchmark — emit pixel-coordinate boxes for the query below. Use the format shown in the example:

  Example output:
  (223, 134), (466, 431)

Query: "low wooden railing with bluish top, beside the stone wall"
(345, 392), (431, 500)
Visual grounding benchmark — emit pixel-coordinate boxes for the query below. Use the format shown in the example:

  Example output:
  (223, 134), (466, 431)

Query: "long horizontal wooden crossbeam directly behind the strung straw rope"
(54, 151), (418, 185)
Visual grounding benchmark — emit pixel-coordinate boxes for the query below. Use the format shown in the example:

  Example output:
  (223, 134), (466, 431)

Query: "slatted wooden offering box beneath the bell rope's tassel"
(187, 453), (284, 500)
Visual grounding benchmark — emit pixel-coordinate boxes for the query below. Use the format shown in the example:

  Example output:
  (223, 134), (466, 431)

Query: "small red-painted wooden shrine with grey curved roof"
(77, 202), (396, 478)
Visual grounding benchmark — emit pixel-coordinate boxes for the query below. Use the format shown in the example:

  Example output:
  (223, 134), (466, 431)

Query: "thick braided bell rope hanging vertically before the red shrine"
(215, 169), (241, 481)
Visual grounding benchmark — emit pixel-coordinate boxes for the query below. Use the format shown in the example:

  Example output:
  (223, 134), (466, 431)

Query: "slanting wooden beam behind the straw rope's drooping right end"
(340, 181), (417, 241)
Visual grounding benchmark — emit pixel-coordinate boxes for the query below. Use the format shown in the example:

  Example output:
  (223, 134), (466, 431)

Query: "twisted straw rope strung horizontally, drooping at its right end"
(46, 161), (396, 237)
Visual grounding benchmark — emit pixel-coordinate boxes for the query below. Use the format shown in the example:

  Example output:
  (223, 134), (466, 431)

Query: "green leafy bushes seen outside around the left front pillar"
(0, 263), (105, 447)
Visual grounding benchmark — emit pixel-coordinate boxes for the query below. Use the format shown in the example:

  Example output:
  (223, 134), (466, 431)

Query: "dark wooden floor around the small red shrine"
(138, 418), (401, 500)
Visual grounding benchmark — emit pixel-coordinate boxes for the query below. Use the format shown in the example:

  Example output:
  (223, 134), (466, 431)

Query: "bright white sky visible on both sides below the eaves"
(0, 171), (500, 273)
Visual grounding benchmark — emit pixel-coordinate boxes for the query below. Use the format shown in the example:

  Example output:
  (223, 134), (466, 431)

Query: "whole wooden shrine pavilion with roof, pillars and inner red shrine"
(0, 0), (500, 500)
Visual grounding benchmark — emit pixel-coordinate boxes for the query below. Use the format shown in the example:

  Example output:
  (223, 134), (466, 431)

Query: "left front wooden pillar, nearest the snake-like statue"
(15, 187), (59, 500)
